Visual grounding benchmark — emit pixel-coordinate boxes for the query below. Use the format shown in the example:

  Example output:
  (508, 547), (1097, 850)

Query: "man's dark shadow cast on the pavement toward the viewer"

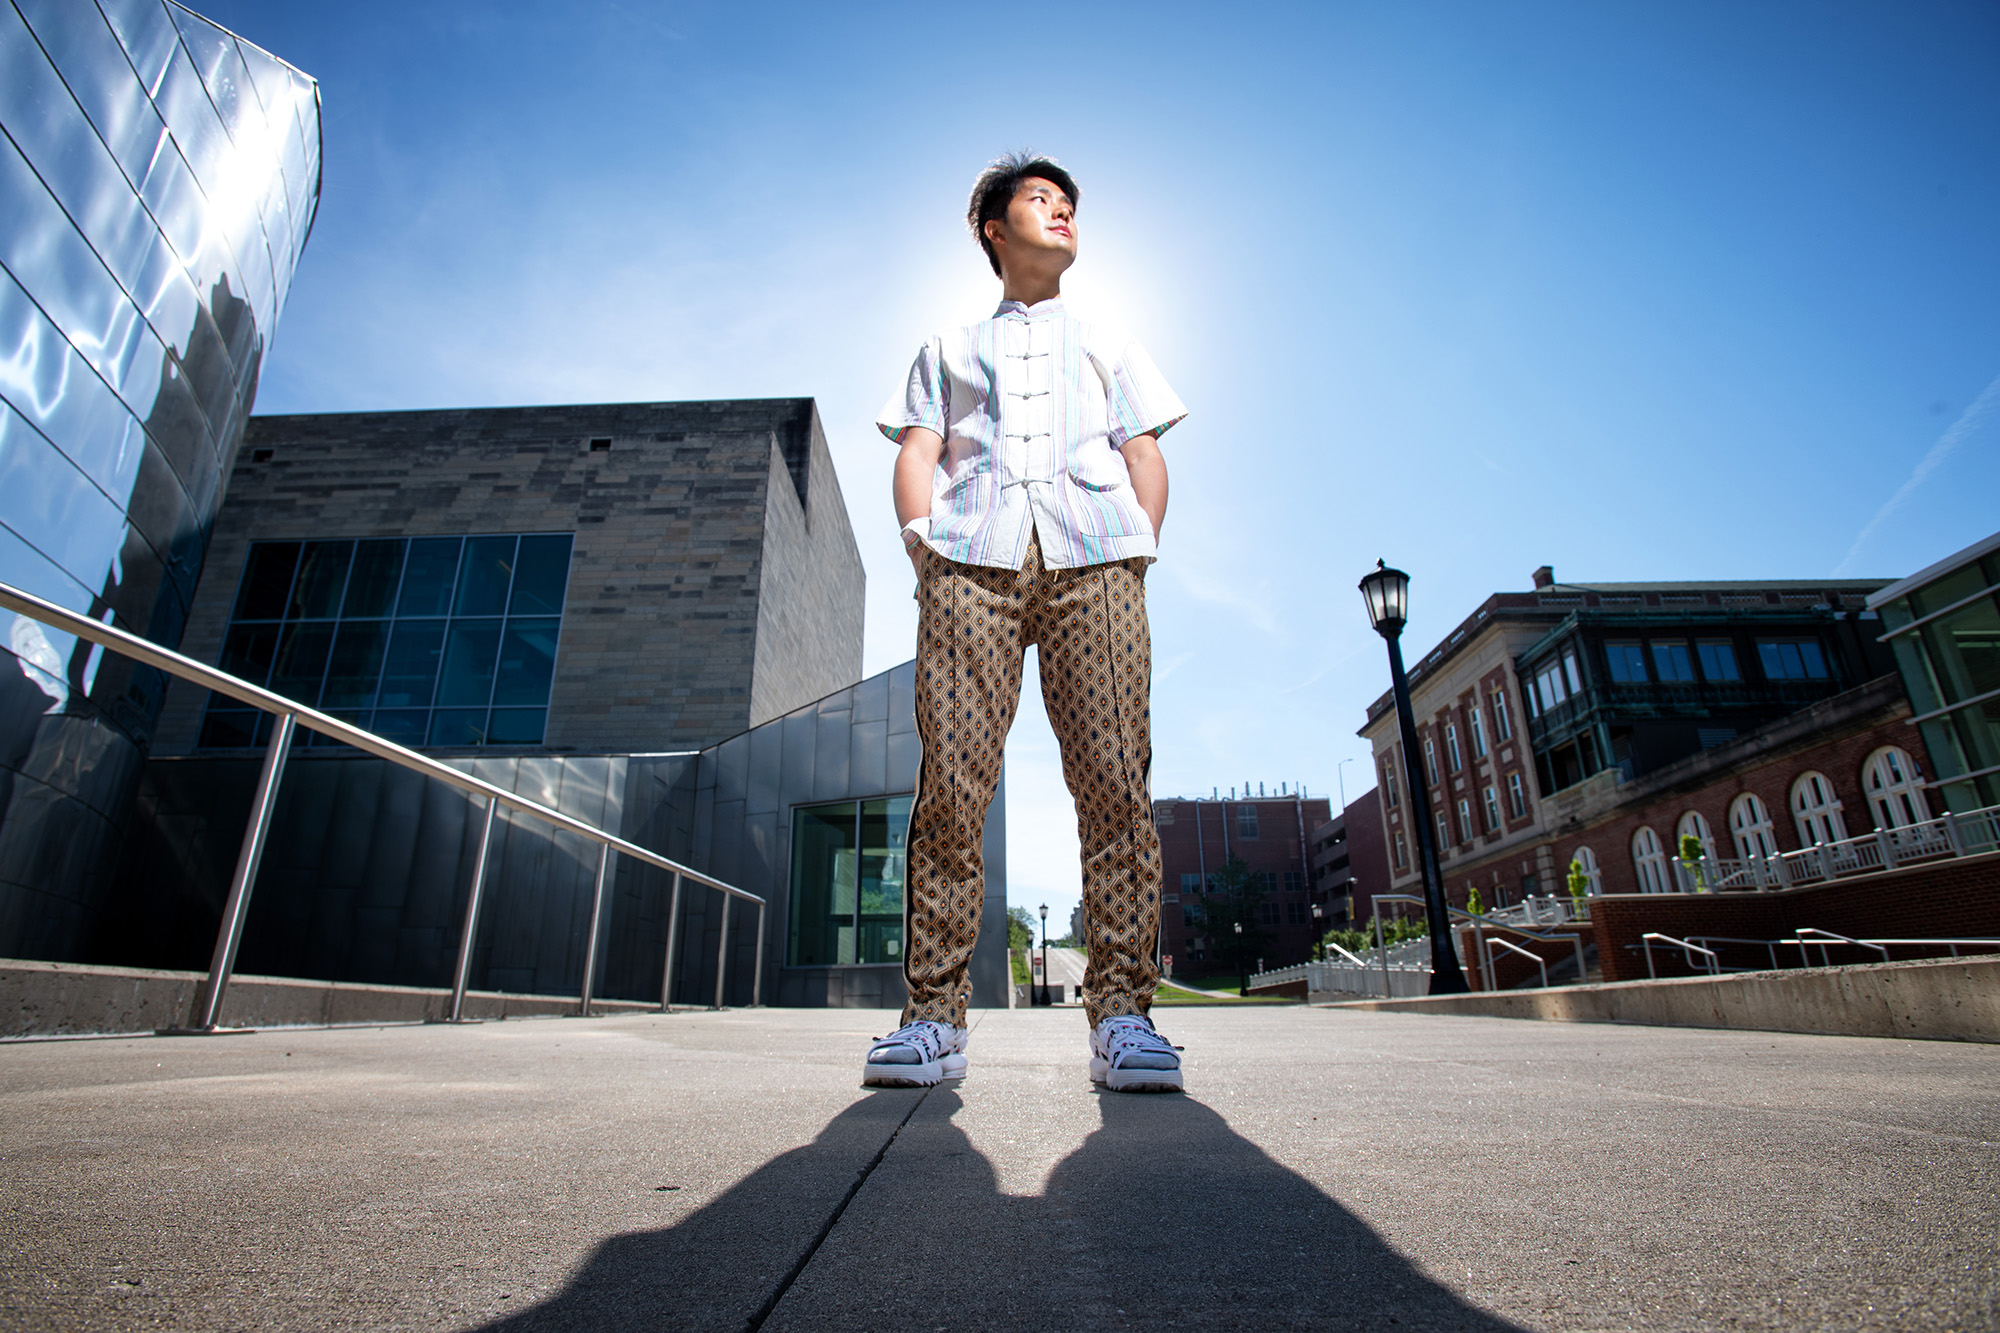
(486, 1089), (1518, 1333)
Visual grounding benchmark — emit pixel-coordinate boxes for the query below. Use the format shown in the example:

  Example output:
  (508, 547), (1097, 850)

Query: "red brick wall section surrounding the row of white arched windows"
(1544, 704), (1920, 893)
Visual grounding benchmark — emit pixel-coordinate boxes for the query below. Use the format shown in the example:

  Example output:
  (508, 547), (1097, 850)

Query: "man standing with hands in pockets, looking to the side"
(862, 154), (1186, 1093)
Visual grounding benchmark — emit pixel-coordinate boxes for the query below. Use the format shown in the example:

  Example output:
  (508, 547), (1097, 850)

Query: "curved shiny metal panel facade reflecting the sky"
(0, 0), (320, 959)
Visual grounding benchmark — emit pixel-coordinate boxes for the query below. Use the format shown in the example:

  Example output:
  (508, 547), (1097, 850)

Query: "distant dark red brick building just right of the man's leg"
(1152, 789), (1332, 977)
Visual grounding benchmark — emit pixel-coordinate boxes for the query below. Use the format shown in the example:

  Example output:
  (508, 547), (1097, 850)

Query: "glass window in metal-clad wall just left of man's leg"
(788, 792), (910, 967)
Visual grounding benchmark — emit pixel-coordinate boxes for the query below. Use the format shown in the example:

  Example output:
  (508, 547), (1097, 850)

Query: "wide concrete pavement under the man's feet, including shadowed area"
(0, 1007), (2000, 1331)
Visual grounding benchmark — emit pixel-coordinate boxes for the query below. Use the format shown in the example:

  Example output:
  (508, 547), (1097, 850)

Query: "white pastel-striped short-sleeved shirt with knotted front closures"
(876, 298), (1188, 568)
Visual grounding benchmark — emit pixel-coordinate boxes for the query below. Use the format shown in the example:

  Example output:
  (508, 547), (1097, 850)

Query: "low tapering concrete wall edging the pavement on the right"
(1338, 957), (2000, 1041)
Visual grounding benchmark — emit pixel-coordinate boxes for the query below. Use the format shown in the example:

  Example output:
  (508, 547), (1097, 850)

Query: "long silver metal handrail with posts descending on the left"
(0, 582), (766, 1020)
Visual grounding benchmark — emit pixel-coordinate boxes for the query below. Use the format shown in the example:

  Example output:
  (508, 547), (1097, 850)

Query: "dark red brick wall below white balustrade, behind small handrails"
(1592, 853), (2000, 981)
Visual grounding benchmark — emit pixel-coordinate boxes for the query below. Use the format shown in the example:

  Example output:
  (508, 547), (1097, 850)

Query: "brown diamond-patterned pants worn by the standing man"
(902, 540), (1160, 1027)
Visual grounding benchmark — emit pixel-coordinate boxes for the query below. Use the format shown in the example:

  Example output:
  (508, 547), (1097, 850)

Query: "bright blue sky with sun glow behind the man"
(198, 0), (2000, 921)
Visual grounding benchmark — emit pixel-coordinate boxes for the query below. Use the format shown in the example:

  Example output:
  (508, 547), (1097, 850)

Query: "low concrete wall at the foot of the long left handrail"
(0, 959), (656, 1039)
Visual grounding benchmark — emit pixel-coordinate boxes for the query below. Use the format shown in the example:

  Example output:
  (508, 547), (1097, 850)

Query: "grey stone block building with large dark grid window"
(154, 398), (864, 755)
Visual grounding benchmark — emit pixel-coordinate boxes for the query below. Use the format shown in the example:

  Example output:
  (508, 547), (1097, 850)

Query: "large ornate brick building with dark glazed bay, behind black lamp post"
(1360, 566), (1922, 905)
